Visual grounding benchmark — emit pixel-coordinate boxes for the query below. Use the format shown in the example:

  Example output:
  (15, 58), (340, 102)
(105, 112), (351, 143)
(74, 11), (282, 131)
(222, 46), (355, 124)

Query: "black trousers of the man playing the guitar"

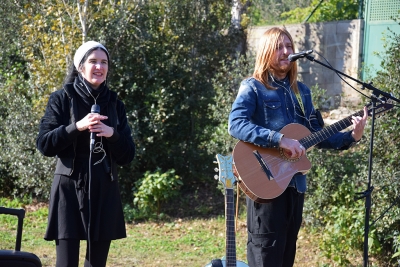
(247, 187), (304, 267)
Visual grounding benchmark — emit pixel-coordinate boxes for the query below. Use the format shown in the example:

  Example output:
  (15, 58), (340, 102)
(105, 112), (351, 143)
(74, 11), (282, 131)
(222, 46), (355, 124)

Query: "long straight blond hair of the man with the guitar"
(253, 27), (299, 93)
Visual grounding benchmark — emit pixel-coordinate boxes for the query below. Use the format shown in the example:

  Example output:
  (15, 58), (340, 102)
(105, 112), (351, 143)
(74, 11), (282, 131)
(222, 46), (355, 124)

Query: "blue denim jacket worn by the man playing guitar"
(228, 78), (355, 193)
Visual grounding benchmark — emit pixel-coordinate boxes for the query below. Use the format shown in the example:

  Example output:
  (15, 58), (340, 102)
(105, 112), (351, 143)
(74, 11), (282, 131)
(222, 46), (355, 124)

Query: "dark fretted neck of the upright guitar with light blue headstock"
(225, 189), (236, 267)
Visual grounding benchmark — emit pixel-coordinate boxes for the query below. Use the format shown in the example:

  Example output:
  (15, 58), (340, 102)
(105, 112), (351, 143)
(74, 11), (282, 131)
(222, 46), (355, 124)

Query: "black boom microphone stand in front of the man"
(305, 55), (400, 267)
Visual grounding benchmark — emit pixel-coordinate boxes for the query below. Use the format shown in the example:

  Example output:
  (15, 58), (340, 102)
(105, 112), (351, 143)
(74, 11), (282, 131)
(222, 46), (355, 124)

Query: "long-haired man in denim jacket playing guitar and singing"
(228, 27), (368, 267)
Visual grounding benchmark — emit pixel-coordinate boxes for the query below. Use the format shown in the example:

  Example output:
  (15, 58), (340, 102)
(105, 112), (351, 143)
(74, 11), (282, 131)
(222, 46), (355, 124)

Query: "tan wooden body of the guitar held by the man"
(233, 123), (311, 203)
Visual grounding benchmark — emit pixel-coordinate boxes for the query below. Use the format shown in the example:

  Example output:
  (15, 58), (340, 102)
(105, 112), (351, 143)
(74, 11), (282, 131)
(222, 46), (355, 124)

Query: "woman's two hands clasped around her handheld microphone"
(76, 113), (114, 137)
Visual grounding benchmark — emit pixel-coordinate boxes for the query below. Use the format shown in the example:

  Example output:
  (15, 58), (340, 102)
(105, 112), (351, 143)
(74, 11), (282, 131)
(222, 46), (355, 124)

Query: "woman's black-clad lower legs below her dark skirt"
(56, 239), (111, 267)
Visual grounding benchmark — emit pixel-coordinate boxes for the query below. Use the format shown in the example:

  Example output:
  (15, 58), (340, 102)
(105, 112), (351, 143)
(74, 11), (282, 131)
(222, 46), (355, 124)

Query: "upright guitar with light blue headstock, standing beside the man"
(206, 154), (248, 267)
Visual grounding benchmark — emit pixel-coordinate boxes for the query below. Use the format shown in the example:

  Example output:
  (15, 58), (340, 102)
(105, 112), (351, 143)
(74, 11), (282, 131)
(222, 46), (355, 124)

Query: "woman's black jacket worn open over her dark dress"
(36, 84), (135, 177)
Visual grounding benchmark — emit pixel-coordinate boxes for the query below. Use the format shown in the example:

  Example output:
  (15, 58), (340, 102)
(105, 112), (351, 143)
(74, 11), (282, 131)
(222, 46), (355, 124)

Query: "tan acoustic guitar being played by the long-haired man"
(233, 99), (393, 203)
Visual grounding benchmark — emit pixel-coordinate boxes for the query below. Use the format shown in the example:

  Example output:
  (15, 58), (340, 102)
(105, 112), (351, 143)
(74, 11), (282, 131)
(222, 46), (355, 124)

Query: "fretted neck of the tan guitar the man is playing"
(299, 110), (364, 150)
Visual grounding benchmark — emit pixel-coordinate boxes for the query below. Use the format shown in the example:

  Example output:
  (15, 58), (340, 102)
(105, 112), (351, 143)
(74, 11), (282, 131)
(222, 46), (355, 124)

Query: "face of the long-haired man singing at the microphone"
(271, 34), (293, 74)
